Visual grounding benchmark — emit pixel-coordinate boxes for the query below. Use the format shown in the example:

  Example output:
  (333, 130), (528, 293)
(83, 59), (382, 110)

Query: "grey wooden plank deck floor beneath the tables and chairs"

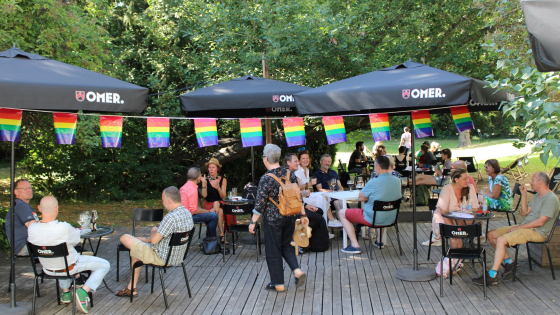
(0, 207), (560, 315)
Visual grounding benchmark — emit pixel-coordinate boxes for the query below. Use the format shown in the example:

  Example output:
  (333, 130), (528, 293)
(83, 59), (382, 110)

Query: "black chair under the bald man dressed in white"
(27, 242), (93, 314)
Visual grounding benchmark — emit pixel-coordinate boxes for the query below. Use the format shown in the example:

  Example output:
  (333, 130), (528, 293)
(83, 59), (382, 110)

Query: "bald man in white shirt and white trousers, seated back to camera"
(27, 196), (111, 313)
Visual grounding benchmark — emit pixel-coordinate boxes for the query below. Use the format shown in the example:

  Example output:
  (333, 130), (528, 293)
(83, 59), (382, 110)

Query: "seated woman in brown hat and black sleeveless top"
(202, 158), (227, 243)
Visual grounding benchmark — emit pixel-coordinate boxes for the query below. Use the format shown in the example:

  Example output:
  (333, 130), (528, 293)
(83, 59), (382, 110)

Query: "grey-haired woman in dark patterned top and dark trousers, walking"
(249, 143), (309, 292)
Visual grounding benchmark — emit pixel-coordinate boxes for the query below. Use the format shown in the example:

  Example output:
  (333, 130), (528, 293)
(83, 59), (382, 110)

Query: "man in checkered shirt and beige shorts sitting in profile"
(116, 186), (194, 297)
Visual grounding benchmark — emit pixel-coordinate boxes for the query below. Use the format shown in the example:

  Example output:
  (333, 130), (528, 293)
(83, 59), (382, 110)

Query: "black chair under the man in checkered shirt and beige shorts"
(130, 227), (196, 309)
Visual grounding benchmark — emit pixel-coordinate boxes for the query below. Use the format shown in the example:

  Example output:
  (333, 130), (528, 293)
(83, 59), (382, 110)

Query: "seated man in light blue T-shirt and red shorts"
(338, 156), (402, 254)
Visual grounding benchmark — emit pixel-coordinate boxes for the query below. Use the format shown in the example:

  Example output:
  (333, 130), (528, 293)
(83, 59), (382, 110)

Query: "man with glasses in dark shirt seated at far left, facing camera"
(4, 179), (39, 256)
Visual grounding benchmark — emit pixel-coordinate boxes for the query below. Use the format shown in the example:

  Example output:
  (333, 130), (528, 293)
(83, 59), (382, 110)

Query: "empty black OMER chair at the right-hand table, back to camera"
(439, 222), (487, 300)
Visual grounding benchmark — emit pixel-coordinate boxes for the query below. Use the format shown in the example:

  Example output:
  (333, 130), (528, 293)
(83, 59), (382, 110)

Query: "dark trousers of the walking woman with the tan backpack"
(263, 215), (299, 285)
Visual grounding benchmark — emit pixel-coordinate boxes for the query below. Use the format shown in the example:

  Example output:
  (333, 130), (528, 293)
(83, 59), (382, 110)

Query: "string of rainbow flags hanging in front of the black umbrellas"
(0, 106), (474, 148)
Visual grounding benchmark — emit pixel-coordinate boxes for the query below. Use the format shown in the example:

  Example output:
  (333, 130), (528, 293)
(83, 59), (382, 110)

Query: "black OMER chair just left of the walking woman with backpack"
(222, 203), (262, 262)
